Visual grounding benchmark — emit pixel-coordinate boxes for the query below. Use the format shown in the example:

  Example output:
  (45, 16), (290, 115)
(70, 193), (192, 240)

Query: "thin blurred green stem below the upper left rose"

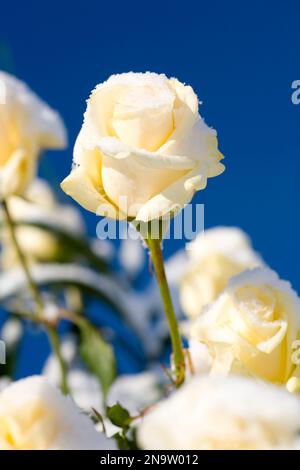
(2, 197), (69, 394)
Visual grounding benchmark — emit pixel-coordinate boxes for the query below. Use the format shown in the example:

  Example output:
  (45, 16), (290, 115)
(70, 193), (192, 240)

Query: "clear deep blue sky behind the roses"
(0, 0), (300, 374)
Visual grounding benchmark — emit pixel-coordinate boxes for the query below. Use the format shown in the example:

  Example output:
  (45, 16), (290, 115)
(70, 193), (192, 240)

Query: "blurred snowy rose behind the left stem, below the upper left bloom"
(0, 179), (84, 270)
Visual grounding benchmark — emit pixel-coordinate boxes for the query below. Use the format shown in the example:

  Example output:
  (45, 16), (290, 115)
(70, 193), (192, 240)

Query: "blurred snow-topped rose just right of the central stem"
(179, 227), (262, 318)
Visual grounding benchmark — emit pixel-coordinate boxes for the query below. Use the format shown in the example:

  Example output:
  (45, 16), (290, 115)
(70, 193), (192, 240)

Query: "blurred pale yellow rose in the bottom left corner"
(0, 377), (114, 450)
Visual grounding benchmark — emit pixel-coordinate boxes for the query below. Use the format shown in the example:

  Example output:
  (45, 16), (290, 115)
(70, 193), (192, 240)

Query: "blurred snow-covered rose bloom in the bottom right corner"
(137, 376), (300, 450)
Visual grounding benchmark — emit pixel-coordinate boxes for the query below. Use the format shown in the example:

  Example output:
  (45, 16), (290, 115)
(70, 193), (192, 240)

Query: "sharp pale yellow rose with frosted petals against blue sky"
(62, 72), (224, 222)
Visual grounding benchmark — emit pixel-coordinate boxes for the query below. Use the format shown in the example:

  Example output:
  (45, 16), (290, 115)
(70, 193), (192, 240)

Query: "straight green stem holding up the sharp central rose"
(146, 236), (185, 387)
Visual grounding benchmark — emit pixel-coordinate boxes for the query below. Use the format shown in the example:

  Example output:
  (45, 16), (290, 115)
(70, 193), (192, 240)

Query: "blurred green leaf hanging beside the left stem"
(78, 321), (116, 395)
